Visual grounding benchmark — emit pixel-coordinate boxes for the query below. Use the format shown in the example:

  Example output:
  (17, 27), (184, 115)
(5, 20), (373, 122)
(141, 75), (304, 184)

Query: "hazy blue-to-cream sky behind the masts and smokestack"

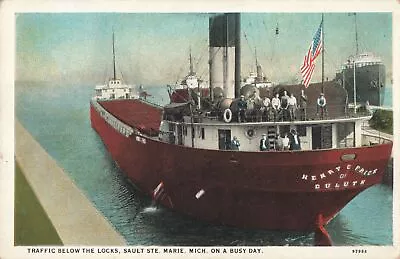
(16, 13), (392, 85)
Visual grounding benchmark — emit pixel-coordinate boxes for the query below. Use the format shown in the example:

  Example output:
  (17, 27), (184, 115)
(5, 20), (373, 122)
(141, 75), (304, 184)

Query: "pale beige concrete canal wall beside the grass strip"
(15, 122), (126, 246)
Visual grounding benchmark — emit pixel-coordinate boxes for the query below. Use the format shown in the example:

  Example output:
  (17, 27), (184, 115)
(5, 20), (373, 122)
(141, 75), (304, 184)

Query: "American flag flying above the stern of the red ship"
(300, 21), (322, 88)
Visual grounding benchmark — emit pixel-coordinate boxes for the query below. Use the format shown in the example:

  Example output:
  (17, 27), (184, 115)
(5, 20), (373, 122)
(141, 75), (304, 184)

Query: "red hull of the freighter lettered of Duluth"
(90, 100), (392, 230)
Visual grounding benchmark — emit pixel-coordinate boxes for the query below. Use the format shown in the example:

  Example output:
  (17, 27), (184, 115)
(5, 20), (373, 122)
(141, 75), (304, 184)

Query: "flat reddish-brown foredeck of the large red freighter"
(99, 99), (162, 136)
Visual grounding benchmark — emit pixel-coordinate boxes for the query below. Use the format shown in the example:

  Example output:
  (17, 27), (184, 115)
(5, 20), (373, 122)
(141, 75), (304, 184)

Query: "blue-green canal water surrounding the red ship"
(15, 84), (392, 246)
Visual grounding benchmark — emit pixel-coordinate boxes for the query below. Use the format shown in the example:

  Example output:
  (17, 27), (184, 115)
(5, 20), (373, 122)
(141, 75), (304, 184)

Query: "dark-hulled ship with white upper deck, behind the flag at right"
(335, 13), (386, 107)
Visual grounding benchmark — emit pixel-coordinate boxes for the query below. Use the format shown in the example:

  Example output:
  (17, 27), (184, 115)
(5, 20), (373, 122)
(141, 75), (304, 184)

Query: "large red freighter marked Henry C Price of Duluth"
(90, 14), (392, 246)
